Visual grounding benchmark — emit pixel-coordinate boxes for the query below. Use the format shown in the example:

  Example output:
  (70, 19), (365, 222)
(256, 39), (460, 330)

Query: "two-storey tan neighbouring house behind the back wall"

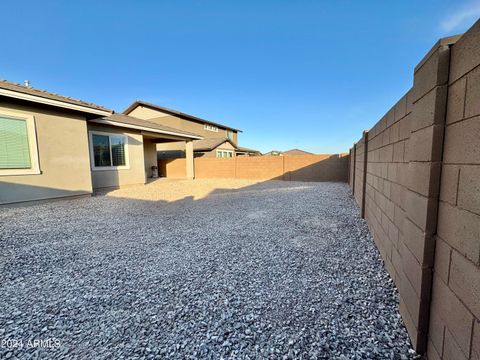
(123, 100), (258, 159)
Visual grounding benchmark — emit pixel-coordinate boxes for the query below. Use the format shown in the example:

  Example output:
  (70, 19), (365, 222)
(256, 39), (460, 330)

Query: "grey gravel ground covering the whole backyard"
(0, 180), (415, 359)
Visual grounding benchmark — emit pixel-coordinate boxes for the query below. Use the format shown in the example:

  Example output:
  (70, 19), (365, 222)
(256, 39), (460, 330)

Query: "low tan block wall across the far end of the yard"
(159, 154), (348, 182)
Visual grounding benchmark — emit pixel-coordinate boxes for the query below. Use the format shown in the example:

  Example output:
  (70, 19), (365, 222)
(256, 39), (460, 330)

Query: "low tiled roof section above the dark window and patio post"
(89, 114), (202, 139)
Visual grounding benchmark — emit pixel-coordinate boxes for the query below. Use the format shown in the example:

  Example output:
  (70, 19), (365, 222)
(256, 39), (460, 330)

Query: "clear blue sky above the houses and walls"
(0, 0), (480, 153)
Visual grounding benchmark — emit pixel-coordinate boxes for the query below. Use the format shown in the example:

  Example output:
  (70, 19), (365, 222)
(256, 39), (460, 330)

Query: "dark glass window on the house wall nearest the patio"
(90, 132), (128, 170)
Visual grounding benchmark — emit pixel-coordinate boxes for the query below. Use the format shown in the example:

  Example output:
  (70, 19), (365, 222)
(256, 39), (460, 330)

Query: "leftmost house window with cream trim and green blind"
(0, 111), (40, 175)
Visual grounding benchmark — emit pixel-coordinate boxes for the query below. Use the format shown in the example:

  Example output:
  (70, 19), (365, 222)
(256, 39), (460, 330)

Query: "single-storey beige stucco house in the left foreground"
(0, 81), (203, 204)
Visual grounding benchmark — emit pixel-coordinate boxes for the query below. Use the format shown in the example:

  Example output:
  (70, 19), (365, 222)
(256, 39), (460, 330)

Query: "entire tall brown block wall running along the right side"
(349, 19), (480, 359)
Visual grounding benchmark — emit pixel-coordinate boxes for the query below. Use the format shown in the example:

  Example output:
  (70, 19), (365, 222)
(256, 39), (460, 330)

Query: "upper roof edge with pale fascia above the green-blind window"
(0, 80), (113, 115)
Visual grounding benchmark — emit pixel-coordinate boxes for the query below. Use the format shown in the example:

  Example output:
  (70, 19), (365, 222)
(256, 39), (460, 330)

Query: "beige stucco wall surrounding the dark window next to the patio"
(88, 123), (146, 189)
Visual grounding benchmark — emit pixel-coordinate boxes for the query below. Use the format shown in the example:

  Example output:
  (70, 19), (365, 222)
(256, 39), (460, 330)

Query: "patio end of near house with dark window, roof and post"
(88, 114), (202, 189)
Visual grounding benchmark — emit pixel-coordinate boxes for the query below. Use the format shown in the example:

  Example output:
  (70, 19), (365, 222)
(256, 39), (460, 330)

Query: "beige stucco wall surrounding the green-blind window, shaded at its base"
(0, 99), (92, 204)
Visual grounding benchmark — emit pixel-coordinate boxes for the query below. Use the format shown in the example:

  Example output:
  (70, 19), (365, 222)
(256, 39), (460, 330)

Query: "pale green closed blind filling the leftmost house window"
(0, 116), (31, 169)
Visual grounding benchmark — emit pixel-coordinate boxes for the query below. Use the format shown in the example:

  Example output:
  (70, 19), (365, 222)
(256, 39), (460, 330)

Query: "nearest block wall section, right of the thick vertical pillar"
(428, 22), (480, 360)
